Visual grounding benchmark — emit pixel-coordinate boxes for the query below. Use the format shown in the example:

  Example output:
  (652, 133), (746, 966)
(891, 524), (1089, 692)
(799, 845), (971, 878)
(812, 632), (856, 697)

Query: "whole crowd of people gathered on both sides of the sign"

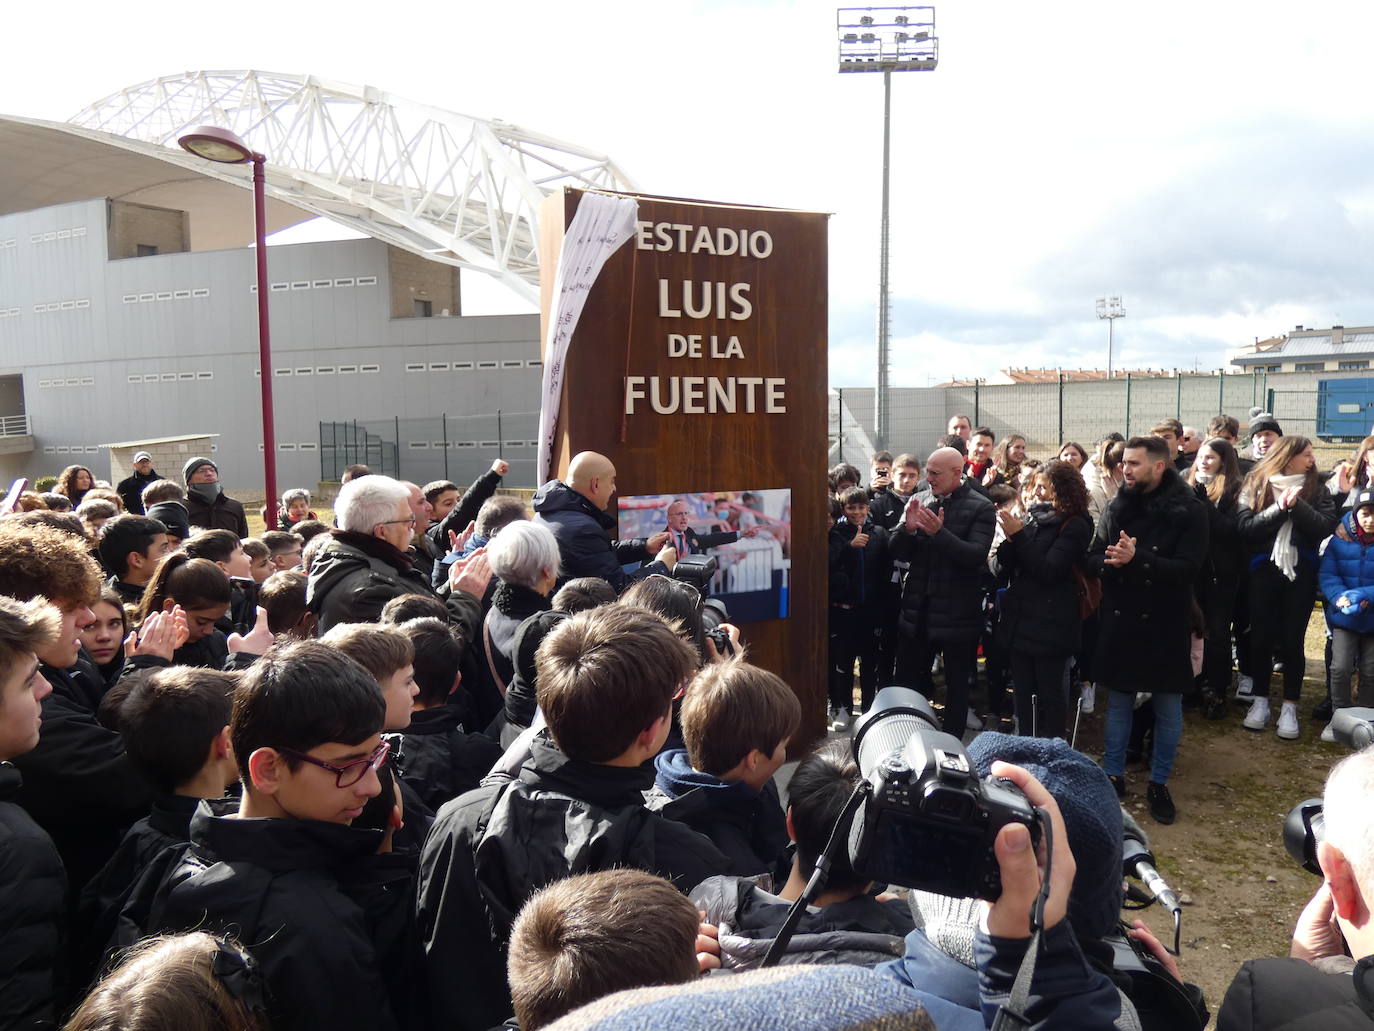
(0, 434), (1374, 1031)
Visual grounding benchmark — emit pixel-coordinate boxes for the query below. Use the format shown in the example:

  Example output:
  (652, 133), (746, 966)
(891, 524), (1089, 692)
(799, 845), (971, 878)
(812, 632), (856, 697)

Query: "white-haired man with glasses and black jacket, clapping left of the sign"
(305, 474), (491, 641)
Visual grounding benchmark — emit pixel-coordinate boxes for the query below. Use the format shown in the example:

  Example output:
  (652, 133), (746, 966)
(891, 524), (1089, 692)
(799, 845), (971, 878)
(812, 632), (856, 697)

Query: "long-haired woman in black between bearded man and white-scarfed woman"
(1187, 437), (1248, 719)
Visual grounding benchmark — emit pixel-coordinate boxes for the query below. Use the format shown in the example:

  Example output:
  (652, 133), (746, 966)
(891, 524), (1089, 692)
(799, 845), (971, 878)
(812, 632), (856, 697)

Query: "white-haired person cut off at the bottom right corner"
(1216, 748), (1374, 1031)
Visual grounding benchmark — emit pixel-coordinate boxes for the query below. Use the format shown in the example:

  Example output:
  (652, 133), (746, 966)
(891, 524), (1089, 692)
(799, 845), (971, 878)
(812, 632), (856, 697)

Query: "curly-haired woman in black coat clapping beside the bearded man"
(996, 459), (1092, 737)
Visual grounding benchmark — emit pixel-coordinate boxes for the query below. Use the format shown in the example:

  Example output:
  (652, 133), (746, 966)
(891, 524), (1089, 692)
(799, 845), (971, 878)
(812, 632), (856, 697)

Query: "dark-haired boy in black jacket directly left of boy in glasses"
(77, 665), (238, 979)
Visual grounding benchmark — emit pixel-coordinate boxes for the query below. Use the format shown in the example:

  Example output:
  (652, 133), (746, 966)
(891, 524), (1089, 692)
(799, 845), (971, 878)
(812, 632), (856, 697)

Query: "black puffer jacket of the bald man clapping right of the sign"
(890, 480), (998, 643)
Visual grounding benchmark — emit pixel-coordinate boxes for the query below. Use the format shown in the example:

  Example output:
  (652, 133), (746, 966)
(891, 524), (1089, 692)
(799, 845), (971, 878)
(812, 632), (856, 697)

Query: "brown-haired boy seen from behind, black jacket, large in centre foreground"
(418, 605), (728, 1031)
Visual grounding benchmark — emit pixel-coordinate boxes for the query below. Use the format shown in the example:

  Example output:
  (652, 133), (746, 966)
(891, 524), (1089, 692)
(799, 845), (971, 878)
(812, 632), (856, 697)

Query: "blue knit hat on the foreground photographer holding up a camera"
(969, 731), (1123, 940)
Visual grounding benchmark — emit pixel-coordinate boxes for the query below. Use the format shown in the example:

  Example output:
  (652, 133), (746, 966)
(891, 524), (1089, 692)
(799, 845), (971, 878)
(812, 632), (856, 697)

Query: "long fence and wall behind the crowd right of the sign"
(830, 373), (1374, 465)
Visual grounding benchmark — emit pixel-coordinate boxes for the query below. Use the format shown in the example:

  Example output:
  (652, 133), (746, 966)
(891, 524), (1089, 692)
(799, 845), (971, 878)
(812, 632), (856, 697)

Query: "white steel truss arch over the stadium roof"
(70, 70), (635, 302)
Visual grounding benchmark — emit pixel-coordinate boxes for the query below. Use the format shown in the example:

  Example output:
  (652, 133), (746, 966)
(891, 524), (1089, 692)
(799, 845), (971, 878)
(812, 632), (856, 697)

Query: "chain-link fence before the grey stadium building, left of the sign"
(320, 411), (539, 488)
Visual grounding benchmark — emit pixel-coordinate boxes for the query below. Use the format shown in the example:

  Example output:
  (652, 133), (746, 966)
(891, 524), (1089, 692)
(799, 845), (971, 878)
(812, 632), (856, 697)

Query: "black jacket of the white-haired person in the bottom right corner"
(1216, 957), (1374, 1031)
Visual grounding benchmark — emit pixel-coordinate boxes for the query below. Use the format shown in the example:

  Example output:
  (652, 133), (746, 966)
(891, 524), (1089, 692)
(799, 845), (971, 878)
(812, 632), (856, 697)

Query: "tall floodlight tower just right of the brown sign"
(835, 7), (940, 448)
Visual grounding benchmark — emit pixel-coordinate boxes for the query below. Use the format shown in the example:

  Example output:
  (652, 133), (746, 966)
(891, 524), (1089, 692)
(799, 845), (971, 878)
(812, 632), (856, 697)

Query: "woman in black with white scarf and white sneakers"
(1235, 437), (1338, 741)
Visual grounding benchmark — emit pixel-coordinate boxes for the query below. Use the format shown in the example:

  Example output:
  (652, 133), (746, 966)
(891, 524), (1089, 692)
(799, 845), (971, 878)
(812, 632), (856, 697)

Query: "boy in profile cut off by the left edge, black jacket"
(0, 595), (67, 1028)
